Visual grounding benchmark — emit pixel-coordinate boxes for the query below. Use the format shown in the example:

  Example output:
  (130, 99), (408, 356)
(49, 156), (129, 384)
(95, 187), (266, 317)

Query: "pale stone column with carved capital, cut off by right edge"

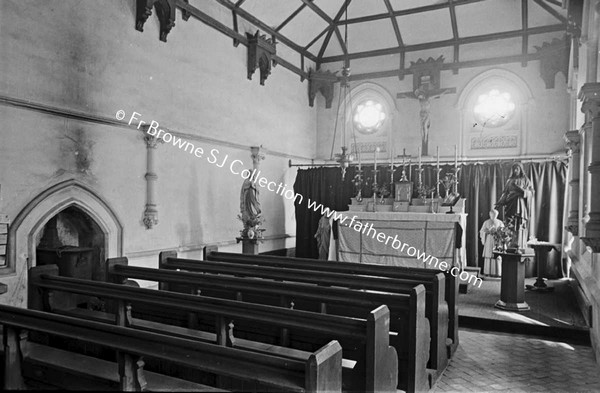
(579, 82), (600, 253)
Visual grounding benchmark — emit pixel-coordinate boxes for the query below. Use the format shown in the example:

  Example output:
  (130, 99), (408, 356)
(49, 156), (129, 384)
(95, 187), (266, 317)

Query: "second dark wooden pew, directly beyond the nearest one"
(30, 264), (398, 392)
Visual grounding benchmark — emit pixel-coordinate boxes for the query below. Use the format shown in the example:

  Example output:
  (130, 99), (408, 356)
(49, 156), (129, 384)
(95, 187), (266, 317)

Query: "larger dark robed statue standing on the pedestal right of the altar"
(495, 162), (534, 249)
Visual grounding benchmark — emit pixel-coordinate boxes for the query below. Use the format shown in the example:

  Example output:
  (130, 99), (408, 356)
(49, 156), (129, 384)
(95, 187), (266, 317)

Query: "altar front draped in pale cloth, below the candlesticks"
(330, 211), (467, 269)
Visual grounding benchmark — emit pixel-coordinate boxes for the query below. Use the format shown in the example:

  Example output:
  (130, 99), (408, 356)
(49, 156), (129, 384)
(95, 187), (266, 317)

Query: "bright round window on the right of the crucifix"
(473, 89), (516, 127)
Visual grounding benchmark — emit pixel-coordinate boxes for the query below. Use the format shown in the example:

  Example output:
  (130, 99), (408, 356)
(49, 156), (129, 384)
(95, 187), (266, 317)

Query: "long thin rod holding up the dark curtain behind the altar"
(288, 154), (569, 168)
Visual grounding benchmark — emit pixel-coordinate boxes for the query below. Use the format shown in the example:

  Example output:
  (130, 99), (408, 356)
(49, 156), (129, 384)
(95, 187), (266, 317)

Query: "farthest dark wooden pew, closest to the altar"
(204, 246), (459, 357)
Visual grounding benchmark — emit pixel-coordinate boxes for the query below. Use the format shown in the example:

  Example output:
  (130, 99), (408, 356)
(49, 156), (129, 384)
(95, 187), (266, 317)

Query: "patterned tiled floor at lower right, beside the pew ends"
(433, 330), (600, 392)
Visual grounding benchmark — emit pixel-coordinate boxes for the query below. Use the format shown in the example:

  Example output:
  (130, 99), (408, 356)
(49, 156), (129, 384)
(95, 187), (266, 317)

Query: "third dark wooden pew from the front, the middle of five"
(107, 260), (430, 392)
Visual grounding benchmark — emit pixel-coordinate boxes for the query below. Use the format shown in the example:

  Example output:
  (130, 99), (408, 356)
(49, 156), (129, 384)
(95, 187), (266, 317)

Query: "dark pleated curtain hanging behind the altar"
(294, 161), (567, 278)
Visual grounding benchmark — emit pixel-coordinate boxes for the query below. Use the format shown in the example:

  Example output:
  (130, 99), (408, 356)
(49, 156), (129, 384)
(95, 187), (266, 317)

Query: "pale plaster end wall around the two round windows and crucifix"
(317, 58), (570, 159)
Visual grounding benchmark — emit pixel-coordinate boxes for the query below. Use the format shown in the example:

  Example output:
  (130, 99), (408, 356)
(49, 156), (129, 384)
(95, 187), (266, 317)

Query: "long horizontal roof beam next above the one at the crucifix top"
(321, 24), (565, 63)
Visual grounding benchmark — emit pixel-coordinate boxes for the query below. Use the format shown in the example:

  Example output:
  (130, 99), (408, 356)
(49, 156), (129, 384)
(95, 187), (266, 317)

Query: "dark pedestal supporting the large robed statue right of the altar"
(494, 252), (533, 311)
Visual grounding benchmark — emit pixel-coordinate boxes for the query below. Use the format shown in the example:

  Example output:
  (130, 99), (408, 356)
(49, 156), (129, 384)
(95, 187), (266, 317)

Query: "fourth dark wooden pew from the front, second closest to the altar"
(159, 251), (449, 379)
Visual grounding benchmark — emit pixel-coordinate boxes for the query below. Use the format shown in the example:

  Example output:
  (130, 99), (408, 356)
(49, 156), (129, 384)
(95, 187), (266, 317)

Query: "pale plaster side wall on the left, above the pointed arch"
(0, 0), (316, 306)
